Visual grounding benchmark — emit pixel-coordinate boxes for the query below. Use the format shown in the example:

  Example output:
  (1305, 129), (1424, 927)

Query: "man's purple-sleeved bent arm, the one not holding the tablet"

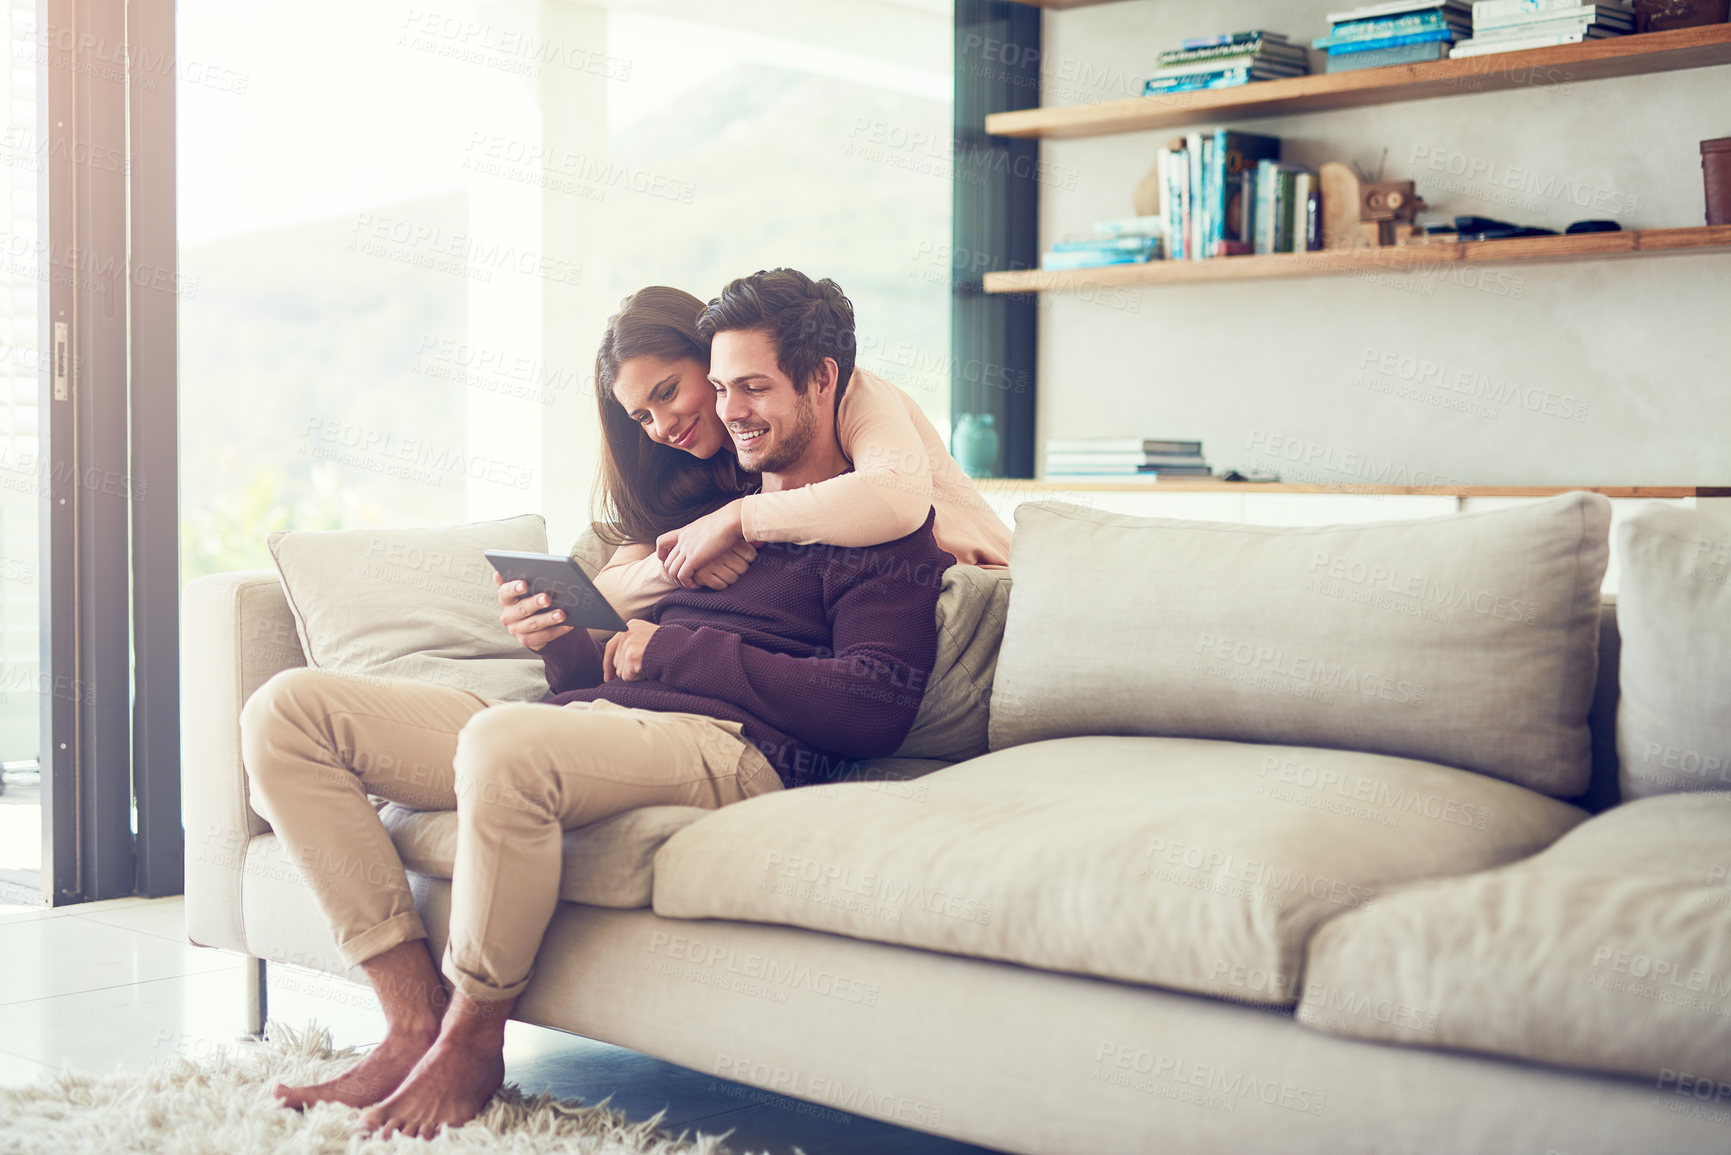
(642, 535), (954, 758)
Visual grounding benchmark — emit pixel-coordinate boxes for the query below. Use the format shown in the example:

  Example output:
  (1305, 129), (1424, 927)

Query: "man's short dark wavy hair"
(698, 268), (855, 405)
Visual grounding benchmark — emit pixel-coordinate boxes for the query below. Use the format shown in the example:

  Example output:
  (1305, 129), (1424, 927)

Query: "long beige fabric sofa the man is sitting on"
(183, 494), (1731, 1155)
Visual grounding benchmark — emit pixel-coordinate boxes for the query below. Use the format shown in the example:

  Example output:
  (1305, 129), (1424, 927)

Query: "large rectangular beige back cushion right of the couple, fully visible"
(992, 494), (1610, 797)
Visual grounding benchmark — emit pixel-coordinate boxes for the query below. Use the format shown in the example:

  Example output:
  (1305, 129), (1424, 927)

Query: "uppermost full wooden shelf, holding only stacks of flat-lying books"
(985, 24), (1731, 139)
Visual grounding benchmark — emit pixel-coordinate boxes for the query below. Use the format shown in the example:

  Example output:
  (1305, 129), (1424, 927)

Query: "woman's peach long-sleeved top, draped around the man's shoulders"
(595, 369), (1009, 618)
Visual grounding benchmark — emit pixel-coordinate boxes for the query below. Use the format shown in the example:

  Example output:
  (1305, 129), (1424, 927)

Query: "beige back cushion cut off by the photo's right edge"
(1617, 506), (1731, 798)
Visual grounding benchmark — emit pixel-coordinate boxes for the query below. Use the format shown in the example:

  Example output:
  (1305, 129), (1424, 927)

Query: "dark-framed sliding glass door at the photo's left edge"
(0, 0), (183, 909)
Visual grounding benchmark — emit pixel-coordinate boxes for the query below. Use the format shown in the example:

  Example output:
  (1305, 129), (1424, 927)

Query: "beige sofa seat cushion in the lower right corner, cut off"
(1298, 793), (1731, 1089)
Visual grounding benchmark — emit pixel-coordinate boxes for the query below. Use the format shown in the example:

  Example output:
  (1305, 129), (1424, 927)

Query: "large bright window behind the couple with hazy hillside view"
(178, 0), (952, 580)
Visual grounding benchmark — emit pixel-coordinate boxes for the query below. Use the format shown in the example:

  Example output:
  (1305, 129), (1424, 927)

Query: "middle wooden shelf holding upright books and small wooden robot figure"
(985, 225), (1731, 293)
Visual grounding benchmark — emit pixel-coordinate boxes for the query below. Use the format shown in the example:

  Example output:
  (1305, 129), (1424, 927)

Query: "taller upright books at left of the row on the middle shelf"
(1155, 128), (1281, 260)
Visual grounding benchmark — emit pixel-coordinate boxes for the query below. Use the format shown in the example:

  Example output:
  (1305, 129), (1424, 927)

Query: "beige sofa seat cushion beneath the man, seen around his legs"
(379, 802), (711, 911)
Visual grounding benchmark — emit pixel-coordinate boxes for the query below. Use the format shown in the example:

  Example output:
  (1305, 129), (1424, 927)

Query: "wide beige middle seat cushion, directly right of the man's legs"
(654, 738), (1586, 1006)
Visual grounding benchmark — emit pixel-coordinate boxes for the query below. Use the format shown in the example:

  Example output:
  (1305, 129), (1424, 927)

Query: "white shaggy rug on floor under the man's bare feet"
(0, 1023), (751, 1155)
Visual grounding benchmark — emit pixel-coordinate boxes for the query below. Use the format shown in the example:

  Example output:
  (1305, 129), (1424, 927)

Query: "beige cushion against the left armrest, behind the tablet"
(267, 514), (547, 701)
